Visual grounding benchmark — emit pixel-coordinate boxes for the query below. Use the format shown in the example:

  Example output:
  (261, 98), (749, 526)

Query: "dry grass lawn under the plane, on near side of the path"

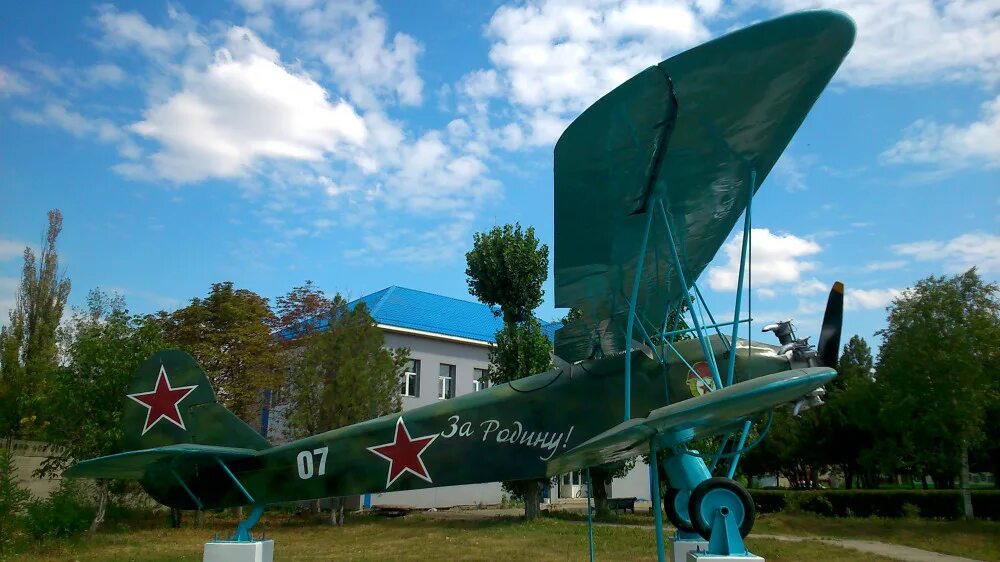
(5, 514), (890, 562)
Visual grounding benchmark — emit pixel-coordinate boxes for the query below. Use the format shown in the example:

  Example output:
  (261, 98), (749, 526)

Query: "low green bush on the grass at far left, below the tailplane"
(24, 480), (94, 540)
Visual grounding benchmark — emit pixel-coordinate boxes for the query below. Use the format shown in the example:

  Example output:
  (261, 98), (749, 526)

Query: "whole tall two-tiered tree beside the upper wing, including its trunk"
(465, 224), (552, 520)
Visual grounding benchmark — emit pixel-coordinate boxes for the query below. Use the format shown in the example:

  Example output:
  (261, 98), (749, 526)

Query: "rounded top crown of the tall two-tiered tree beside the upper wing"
(465, 223), (549, 322)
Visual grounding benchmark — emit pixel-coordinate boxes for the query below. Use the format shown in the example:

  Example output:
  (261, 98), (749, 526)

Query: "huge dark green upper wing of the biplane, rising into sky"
(555, 11), (854, 361)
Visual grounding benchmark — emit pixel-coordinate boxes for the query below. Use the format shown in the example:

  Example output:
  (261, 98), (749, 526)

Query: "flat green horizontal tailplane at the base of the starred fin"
(63, 444), (257, 480)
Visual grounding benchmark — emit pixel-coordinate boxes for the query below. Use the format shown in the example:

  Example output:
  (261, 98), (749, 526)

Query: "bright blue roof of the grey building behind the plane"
(282, 285), (562, 343)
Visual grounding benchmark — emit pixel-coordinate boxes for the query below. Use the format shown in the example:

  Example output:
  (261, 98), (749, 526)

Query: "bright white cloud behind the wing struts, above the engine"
(708, 228), (821, 291)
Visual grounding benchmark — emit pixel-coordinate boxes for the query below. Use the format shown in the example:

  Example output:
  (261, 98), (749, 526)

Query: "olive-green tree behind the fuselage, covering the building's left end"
(288, 295), (409, 525)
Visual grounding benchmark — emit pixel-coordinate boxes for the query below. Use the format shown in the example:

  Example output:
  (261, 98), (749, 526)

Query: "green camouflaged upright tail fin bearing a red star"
(122, 349), (271, 451)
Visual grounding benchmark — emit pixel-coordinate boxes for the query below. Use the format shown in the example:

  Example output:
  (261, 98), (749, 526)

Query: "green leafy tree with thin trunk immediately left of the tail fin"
(41, 290), (165, 536)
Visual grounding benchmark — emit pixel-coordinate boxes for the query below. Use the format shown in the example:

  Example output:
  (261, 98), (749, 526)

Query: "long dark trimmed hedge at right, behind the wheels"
(750, 490), (1000, 520)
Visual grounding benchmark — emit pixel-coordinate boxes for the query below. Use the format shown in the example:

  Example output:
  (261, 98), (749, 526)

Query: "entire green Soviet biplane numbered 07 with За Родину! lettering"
(66, 11), (854, 556)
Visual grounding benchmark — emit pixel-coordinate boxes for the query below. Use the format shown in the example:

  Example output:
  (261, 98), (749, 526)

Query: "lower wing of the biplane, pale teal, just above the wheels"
(546, 367), (837, 475)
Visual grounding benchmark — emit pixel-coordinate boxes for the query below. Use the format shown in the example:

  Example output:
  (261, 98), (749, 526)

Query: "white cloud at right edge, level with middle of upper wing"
(881, 94), (1000, 168)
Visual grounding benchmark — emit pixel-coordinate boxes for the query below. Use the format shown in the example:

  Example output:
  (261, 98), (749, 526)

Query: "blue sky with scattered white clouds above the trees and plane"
(0, 0), (1000, 350)
